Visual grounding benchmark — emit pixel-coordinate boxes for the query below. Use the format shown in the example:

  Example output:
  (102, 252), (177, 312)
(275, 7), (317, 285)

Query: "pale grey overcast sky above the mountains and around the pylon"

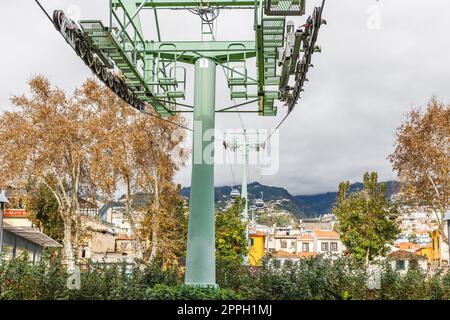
(0, 0), (450, 195)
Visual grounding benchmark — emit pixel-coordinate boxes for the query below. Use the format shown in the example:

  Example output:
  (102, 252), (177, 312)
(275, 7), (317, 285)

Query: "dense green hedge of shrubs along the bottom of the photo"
(0, 255), (450, 300)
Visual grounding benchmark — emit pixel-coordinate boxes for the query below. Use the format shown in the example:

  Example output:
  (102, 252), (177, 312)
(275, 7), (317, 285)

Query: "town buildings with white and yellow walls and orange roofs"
(3, 183), (449, 272)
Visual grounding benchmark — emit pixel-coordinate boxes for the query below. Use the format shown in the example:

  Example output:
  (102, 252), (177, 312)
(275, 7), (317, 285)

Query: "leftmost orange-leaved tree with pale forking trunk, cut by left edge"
(0, 76), (102, 269)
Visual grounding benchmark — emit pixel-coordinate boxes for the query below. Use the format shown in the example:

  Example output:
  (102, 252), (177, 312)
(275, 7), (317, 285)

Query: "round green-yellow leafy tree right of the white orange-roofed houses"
(333, 172), (400, 265)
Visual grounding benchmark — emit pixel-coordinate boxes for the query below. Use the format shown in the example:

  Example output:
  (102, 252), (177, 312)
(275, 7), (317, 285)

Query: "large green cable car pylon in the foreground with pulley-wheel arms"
(49, 0), (324, 287)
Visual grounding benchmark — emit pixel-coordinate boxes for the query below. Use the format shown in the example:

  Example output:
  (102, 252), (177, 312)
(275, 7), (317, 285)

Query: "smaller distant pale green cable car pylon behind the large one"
(225, 129), (264, 265)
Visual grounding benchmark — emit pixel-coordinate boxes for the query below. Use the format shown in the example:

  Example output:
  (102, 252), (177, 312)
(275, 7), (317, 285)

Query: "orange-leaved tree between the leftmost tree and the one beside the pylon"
(75, 80), (145, 259)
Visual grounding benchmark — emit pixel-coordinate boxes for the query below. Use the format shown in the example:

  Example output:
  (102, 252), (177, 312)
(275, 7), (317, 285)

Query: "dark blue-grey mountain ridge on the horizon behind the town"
(181, 181), (399, 218)
